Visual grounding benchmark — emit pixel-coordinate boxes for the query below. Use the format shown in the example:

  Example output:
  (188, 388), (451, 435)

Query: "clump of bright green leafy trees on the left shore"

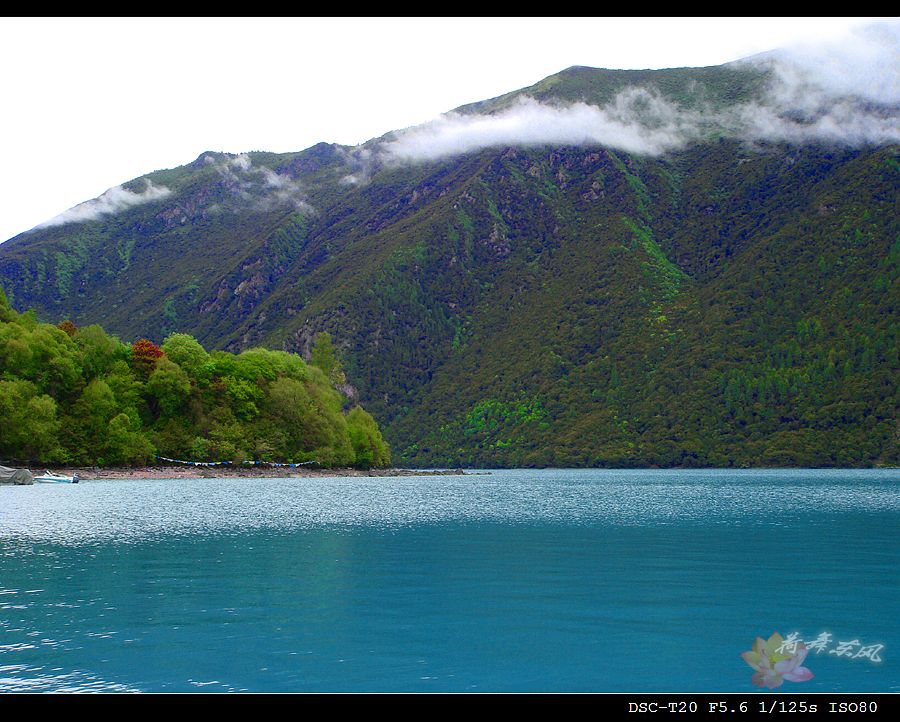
(0, 289), (390, 468)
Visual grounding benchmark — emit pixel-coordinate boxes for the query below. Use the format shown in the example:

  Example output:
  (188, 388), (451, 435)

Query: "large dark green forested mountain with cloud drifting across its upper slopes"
(0, 56), (900, 467)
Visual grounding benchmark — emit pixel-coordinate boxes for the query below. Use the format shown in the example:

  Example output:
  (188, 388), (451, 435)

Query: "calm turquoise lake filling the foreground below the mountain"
(0, 469), (900, 692)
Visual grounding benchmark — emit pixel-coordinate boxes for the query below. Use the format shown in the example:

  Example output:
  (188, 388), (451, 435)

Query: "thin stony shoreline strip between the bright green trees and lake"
(41, 465), (465, 481)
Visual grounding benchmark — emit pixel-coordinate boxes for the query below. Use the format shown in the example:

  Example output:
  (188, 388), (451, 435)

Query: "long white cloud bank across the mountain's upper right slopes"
(380, 23), (900, 167)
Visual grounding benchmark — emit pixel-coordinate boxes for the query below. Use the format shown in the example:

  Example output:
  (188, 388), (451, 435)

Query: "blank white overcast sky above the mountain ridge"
(0, 17), (888, 241)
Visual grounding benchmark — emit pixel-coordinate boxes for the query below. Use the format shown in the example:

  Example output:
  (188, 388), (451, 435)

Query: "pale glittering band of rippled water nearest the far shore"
(0, 469), (900, 554)
